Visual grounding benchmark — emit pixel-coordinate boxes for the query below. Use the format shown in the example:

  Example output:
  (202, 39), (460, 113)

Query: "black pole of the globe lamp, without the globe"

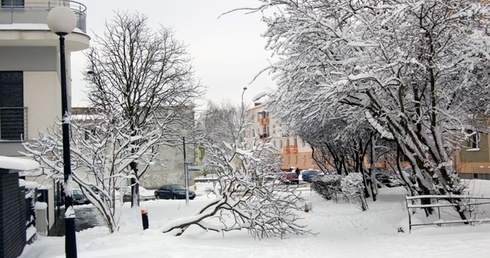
(58, 33), (77, 258)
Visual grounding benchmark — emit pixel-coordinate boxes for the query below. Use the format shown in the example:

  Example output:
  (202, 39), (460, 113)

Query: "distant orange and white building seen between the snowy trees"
(245, 103), (319, 170)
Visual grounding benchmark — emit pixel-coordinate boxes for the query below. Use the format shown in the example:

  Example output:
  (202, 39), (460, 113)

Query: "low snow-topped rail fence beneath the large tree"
(406, 195), (490, 232)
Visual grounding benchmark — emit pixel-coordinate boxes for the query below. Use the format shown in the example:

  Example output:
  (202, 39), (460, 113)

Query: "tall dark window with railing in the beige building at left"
(0, 71), (26, 140)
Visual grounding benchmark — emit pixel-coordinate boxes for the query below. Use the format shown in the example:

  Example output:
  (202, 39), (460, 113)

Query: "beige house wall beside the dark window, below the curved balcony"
(0, 46), (64, 156)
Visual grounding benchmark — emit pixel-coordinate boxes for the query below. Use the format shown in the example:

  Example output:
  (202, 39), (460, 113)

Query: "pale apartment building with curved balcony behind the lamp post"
(0, 0), (90, 236)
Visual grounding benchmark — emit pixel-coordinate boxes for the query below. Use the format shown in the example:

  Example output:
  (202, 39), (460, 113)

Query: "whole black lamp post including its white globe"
(47, 6), (77, 258)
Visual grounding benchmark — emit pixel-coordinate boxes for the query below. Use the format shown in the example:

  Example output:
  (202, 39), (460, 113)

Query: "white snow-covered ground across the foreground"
(21, 180), (490, 258)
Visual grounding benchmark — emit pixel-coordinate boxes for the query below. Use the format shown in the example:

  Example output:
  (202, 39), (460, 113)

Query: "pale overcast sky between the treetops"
(72, 0), (274, 109)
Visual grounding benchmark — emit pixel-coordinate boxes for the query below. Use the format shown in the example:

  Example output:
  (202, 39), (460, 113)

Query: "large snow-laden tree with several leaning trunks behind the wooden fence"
(258, 0), (490, 217)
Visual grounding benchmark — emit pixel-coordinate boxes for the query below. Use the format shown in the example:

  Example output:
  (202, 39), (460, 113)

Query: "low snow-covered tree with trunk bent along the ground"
(162, 137), (310, 239)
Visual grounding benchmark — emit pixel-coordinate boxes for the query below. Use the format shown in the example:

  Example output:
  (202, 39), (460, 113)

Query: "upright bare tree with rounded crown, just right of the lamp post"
(86, 13), (204, 206)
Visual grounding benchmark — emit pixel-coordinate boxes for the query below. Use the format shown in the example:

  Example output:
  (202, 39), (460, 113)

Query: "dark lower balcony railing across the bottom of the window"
(0, 107), (27, 141)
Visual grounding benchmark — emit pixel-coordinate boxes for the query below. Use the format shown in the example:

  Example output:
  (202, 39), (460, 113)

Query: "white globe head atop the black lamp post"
(47, 6), (77, 36)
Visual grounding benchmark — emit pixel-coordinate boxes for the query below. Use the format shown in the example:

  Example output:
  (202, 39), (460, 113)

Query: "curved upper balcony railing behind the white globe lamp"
(0, 0), (87, 32)
